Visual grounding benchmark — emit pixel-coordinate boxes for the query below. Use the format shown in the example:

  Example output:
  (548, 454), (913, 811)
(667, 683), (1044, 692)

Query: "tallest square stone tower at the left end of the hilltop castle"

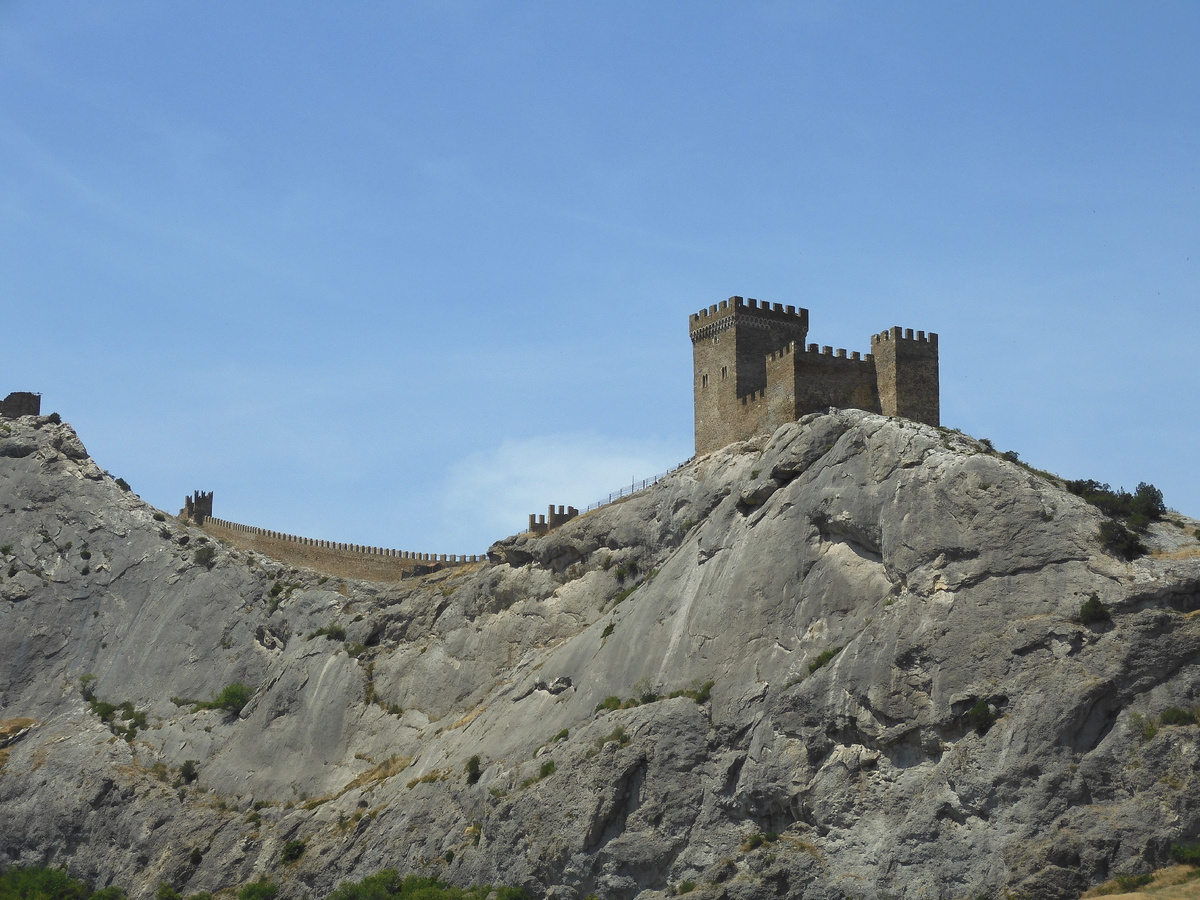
(688, 296), (809, 455)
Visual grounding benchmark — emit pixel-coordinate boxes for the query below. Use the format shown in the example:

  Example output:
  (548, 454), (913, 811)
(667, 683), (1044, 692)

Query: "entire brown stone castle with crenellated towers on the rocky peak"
(688, 296), (941, 456)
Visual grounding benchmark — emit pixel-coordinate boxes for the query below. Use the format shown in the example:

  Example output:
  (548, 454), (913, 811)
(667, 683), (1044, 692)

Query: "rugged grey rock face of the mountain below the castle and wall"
(0, 410), (1200, 900)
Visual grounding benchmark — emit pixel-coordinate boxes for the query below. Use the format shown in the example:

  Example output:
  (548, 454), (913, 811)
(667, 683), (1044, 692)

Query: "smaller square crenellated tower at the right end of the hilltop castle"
(871, 326), (942, 425)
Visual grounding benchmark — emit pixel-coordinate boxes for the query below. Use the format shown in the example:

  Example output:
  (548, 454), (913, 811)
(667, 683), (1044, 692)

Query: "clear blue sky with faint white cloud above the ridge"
(0, 0), (1200, 553)
